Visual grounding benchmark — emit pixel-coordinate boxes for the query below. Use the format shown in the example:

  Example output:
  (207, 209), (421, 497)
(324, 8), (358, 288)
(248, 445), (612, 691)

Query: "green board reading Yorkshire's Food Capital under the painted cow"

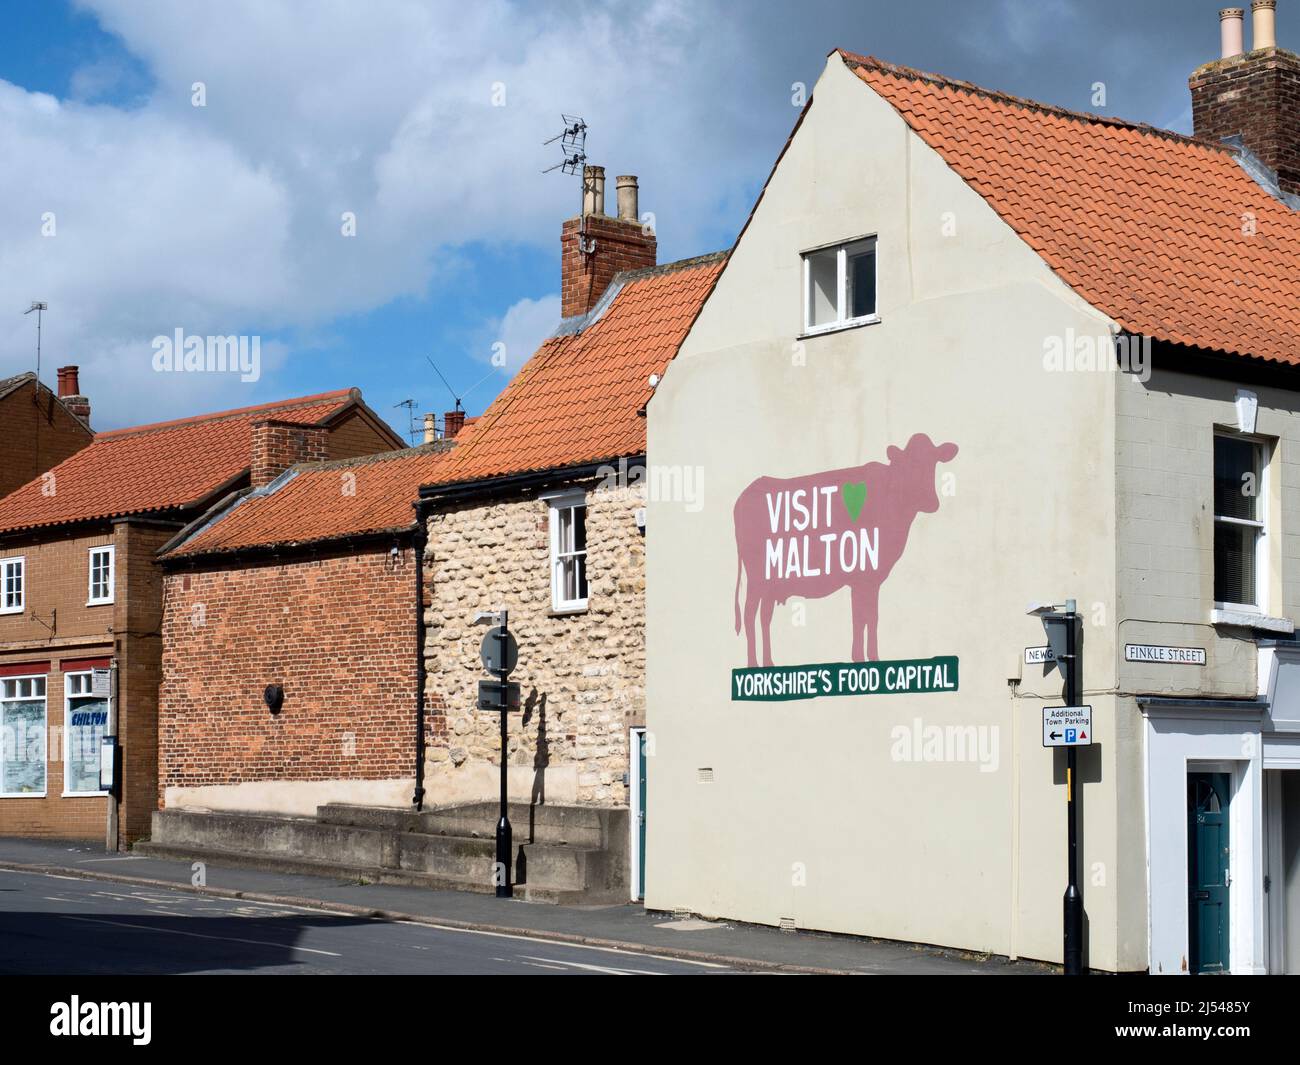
(732, 654), (957, 702)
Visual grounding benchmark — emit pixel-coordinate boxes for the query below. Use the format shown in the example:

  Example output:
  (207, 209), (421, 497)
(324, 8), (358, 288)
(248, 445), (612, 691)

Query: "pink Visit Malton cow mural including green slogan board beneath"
(732, 433), (957, 700)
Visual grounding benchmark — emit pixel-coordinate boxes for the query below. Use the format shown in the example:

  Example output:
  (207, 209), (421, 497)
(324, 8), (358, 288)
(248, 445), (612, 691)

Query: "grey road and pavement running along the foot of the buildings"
(0, 837), (1053, 975)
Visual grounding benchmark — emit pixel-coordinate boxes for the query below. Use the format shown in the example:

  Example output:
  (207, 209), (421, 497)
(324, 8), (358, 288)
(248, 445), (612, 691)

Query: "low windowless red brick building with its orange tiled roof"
(159, 442), (450, 814)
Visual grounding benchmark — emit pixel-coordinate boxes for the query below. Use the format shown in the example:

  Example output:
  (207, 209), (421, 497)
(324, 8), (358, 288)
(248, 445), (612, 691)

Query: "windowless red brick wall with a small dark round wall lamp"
(159, 545), (416, 795)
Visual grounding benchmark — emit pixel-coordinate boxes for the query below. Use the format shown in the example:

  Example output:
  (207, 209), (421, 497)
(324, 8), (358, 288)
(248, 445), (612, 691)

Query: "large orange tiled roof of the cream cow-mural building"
(840, 52), (1300, 364)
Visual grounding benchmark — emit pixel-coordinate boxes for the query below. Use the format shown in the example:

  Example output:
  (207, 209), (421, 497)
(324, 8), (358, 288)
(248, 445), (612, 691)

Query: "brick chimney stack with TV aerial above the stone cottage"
(560, 166), (658, 319)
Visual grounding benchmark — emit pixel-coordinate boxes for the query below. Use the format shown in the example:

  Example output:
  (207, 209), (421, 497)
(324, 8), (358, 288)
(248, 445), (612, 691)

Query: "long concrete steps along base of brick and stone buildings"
(137, 804), (627, 902)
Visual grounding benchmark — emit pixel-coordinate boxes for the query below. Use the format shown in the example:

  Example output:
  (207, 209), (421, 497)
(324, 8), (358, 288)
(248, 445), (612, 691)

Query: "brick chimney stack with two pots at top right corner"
(1188, 0), (1300, 194)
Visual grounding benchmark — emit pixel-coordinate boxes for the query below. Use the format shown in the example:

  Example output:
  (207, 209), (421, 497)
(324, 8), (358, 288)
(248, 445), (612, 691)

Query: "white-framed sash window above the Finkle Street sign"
(1214, 433), (1269, 614)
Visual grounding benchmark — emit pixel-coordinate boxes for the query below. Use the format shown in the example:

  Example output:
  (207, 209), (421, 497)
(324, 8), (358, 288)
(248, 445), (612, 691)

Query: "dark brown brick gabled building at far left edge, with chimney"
(0, 367), (95, 497)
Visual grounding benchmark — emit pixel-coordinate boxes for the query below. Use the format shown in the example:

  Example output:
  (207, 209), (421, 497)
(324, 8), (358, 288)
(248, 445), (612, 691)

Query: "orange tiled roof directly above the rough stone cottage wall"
(438, 252), (725, 484)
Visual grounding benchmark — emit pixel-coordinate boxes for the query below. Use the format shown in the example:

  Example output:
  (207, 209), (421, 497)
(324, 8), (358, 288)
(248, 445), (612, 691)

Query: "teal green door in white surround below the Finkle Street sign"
(1187, 772), (1229, 973)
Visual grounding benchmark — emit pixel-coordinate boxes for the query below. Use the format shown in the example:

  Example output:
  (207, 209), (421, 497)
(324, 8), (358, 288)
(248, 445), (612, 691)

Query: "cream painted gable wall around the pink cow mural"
(646, 56), (1145, 969)
